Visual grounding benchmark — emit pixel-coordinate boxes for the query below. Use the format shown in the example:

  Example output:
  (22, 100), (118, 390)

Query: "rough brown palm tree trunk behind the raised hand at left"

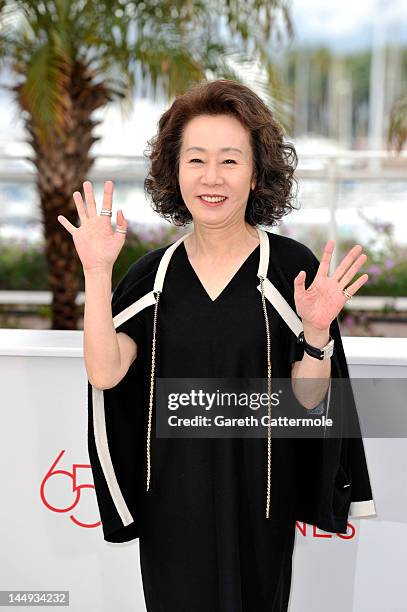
(12, 62), (122, 329)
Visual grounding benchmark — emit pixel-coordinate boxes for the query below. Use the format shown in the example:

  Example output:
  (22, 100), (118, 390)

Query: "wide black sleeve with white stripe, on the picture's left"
(88, 247), (165, 543)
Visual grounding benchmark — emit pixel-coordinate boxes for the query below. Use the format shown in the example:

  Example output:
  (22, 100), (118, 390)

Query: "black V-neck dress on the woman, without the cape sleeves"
(126, 242), (302, 612)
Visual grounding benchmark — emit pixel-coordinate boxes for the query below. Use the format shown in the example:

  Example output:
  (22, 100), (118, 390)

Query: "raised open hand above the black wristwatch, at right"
(294, 240), (369, 330)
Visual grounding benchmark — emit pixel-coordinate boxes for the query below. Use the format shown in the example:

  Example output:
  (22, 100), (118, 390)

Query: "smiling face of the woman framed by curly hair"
(178, 115), (255, 224)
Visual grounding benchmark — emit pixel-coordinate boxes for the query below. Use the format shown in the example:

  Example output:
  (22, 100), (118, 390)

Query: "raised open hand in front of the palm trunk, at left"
(57, 181), (128, 272)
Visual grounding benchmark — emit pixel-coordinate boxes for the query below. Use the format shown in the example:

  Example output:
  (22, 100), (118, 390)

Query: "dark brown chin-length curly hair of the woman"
(144, 79), (298, 227)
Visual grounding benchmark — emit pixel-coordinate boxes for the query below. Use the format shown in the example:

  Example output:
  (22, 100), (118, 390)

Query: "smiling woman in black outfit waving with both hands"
(58, 80), (374, 612)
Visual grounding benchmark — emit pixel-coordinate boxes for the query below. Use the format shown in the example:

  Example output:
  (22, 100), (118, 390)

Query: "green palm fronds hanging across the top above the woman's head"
(0, 0), (292, 135)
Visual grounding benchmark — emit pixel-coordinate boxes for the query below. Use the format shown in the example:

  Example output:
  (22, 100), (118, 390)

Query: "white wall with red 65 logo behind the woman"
(0, 330), (407, 612)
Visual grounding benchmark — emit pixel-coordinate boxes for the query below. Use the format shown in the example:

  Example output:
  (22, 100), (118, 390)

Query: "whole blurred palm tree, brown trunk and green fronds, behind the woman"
(0, 0), (292, 329)
